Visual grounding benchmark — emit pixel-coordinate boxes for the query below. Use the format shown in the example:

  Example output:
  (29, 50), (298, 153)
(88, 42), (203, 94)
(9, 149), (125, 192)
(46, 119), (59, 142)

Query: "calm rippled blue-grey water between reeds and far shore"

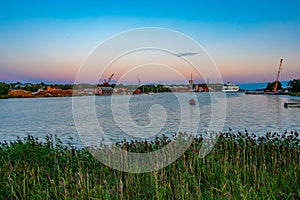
(0, 93), (300, 146)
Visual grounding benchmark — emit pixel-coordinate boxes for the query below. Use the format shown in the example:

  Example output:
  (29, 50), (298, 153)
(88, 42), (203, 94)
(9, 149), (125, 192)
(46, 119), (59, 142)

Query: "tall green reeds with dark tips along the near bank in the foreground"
(0, 132), (300, 199)
